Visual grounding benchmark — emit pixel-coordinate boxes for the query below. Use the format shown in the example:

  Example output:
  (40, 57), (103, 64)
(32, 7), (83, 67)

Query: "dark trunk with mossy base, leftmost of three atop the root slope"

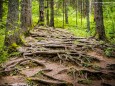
(38, 0), (44, 26)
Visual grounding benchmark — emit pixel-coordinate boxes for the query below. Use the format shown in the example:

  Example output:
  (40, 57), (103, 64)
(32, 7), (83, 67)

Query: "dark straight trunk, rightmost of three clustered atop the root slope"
(50, 0), (54, 27)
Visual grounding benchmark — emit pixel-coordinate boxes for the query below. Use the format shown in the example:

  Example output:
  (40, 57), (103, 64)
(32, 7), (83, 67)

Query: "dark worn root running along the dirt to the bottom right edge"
(72, 69), (115, 80)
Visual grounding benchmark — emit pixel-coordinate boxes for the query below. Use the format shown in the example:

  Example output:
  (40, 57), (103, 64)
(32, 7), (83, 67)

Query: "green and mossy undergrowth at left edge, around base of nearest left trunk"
(0, 28), (20, 64)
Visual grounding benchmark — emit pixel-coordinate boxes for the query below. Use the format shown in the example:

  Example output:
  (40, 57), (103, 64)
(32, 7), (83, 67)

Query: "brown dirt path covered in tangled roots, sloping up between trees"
(0, 27), (115, 86)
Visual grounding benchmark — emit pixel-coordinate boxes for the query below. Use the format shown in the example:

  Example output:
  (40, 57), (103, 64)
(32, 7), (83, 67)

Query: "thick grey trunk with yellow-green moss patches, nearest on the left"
(5, 0), (21, 46)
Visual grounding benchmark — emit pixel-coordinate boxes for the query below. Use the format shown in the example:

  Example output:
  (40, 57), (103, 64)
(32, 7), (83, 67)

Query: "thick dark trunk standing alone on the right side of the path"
(94, 0), (106, 41)
